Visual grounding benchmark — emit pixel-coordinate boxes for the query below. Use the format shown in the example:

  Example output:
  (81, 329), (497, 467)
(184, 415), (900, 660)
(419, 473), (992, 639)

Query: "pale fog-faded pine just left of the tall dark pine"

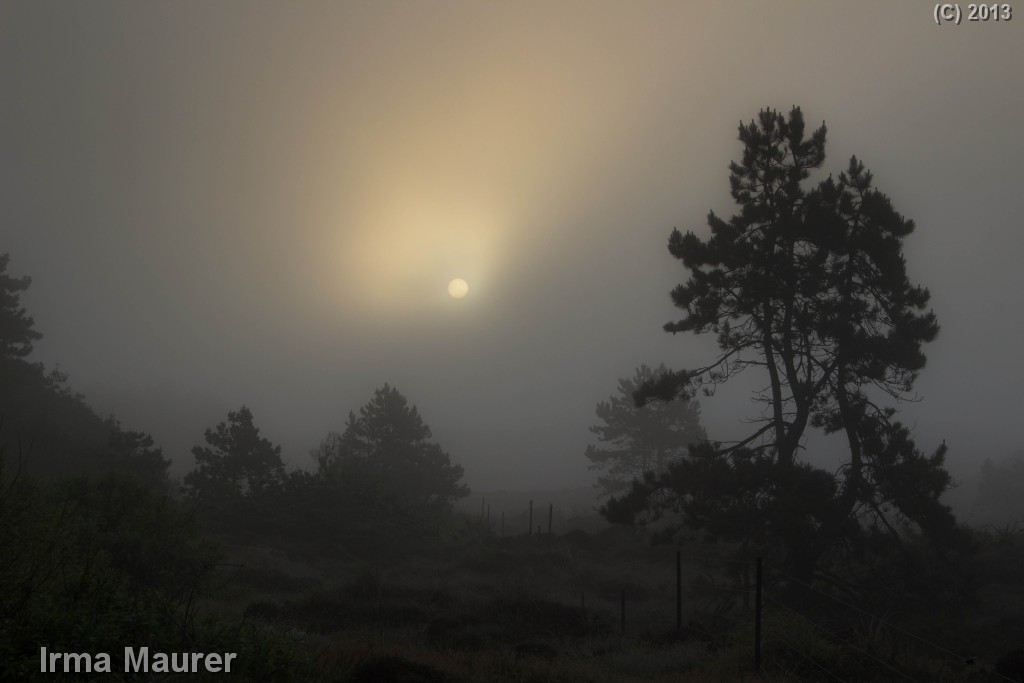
(586, 365), (707, 495)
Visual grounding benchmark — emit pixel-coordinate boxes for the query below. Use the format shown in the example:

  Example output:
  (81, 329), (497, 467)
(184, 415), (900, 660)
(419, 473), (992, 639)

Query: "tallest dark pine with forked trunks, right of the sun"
(605, 108), (955, 572)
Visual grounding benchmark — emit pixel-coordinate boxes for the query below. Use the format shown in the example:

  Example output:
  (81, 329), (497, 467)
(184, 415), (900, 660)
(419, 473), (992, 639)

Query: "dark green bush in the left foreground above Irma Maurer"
(0, 476), (215, 680)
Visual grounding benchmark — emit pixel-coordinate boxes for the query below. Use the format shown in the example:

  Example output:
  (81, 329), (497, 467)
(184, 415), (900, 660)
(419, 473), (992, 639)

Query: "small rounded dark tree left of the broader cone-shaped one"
(184, 405), (285, 500)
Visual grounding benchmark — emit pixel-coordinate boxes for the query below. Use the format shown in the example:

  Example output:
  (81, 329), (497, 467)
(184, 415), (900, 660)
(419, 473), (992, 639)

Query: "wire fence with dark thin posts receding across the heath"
(468, 508), (1019, 683)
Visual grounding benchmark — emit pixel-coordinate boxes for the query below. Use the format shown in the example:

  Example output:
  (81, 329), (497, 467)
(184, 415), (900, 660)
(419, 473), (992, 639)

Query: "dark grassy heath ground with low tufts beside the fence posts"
(193, 520), (1007, 683)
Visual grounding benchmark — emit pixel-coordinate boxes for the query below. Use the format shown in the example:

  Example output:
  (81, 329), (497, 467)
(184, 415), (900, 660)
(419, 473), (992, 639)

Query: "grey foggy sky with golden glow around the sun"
(0, 0), (1024, 489)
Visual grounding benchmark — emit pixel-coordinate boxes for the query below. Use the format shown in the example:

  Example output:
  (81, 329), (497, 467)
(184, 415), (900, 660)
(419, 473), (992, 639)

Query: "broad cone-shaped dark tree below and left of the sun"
(317, 384), (469, 508)
